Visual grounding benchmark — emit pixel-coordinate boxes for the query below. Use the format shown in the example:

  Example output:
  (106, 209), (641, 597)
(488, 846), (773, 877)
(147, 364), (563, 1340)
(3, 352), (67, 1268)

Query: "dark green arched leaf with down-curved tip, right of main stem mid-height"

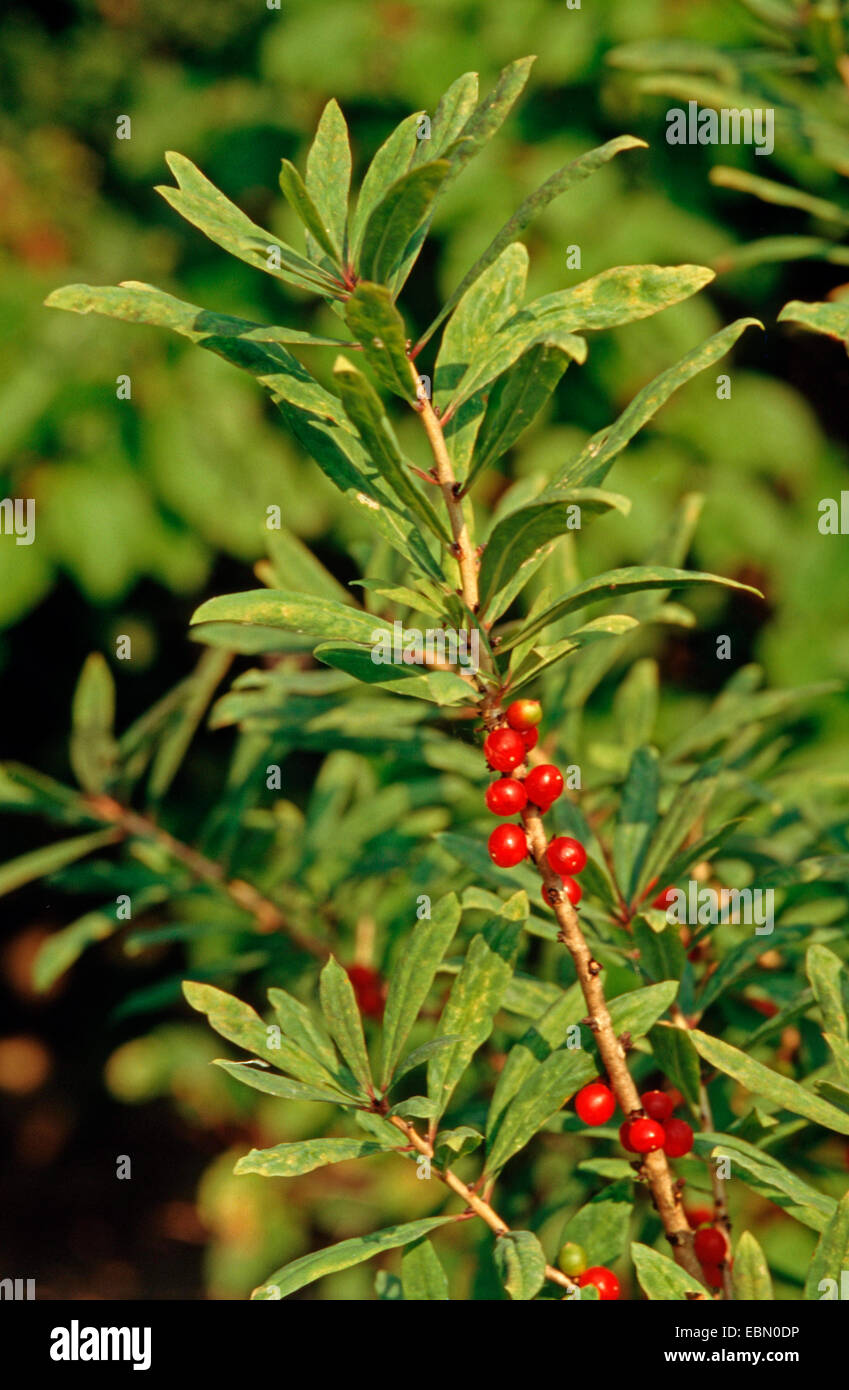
(479, 488), (631, 617)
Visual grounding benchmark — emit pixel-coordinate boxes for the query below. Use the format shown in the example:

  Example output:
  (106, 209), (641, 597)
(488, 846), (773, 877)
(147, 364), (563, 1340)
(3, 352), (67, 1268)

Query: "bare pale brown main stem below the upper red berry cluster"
(522, 805), (703, 1287)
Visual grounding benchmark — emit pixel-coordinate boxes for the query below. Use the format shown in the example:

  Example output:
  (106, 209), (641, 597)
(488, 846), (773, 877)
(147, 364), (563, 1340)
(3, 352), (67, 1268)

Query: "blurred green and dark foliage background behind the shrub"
(0, 0), (849, 1298)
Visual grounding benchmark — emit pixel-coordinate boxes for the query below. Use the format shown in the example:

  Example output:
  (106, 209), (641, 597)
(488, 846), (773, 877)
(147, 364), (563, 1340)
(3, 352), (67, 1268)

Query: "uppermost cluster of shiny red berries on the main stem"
(484, 699), (586, 906)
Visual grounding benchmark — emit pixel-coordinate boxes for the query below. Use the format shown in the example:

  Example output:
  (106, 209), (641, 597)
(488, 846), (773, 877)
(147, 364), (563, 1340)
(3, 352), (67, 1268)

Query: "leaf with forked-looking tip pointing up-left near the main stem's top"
(157, 150), (333, 295)
